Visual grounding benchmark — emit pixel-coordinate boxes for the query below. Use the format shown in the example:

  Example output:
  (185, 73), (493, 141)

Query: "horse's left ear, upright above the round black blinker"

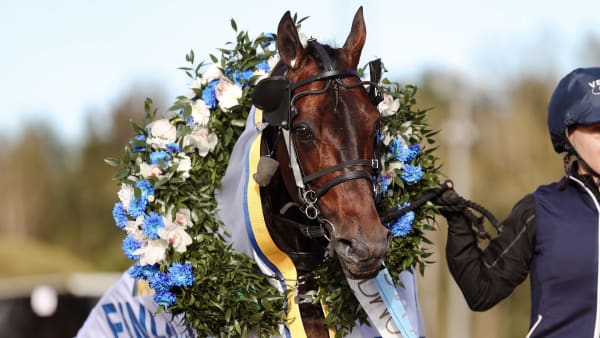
(277, 11), (304, 69)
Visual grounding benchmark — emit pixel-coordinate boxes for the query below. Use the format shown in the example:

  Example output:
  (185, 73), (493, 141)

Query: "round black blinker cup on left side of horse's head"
(252, 76), (292, 129)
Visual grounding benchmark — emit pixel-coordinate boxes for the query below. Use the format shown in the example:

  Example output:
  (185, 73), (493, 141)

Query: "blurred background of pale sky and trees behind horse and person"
(0, 0), (600, 338)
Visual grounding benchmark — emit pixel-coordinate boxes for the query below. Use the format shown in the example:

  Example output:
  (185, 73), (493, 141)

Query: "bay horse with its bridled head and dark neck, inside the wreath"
(253, 7), (391, 337)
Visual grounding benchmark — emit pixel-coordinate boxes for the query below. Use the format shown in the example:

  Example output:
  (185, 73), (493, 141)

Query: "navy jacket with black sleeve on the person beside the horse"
(444, 172), (600, 338)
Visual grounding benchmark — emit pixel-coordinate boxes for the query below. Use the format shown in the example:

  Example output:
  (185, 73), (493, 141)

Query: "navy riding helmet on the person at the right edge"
(548, 67), (600, 153)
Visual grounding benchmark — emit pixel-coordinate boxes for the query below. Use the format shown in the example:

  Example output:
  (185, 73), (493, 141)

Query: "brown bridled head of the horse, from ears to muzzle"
(256, 8), (390, 278)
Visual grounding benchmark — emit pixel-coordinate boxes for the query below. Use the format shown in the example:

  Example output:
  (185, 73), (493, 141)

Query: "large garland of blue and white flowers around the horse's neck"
(106, 20), (441, 337)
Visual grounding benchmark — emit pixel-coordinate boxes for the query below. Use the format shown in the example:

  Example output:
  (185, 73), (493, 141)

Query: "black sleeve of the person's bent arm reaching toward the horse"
(444, 194), (535, 311)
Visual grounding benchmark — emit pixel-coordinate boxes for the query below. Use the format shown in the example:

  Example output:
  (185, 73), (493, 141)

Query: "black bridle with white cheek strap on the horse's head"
(252, 39), (382, 238)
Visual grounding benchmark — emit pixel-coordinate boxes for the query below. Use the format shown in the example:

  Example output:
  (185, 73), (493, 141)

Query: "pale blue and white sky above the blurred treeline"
(0, 0), (600, 143)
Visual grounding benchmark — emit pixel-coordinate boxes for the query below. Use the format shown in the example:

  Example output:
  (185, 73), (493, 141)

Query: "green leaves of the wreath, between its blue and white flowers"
(105, 17), (440, 337)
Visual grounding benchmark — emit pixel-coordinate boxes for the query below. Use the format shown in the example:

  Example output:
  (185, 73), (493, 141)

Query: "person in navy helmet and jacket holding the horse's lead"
(434, 67), (600, 338)
